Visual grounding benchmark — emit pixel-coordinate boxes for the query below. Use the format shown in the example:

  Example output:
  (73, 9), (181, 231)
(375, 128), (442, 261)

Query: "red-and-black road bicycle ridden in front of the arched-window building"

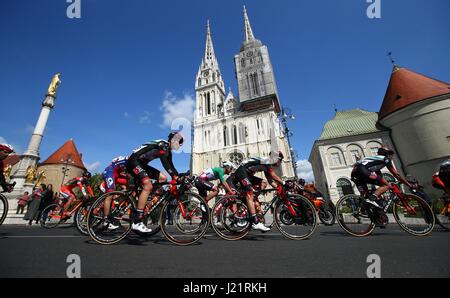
(336, 182), (435, 237)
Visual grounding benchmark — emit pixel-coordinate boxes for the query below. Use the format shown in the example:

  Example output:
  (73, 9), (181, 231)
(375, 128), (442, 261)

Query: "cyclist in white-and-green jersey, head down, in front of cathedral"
(195, 161), (236, 202)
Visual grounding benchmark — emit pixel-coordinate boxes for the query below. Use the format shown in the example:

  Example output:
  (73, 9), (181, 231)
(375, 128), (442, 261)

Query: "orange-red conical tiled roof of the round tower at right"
(380, 67), (450, 119)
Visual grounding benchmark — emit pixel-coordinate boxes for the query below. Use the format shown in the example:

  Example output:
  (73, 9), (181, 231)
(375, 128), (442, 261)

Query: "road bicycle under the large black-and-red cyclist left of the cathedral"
(87, 174), (210, 246)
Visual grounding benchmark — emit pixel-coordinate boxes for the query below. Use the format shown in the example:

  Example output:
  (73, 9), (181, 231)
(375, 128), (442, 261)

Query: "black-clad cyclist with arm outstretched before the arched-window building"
(351, 147), (413, 209)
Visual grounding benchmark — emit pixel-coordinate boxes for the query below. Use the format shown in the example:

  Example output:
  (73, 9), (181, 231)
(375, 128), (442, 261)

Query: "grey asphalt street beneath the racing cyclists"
(0, 224), (450, 278)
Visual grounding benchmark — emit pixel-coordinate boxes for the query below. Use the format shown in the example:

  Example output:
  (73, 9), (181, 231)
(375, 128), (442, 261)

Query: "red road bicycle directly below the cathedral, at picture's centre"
(212, 187), (317, 241)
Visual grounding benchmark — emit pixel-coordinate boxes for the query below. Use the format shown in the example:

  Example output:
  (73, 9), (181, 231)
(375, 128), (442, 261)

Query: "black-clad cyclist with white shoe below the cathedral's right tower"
(232, 151), (284, 232)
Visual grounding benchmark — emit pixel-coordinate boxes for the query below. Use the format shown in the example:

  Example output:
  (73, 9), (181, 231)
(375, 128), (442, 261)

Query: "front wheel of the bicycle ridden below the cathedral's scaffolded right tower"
(273, 195), (317, 240)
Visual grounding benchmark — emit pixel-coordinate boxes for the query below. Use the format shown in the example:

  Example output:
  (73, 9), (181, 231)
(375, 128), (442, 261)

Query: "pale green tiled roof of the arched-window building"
(319, 109), (381, 140)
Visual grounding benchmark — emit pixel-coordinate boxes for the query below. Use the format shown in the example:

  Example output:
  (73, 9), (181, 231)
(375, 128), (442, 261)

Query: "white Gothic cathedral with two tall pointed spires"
(191, 7), (295, 179)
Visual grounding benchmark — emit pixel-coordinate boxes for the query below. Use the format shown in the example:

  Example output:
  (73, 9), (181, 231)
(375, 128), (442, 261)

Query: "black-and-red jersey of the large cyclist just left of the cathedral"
(126, 140), (178, 182)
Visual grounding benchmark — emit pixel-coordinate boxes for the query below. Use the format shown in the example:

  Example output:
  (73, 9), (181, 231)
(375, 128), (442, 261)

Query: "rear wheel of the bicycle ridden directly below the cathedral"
(211, 196), (250, 241)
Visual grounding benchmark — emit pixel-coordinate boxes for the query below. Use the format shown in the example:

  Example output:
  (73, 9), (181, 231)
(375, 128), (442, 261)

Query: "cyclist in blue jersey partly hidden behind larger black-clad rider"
(100, 156), (128, 230)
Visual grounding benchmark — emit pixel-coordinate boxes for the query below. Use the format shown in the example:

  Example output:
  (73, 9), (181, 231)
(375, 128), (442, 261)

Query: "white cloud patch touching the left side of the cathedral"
(160, 92), (195, 127)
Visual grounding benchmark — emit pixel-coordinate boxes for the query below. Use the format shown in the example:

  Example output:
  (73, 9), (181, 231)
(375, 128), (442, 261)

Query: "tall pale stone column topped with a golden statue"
(11, 73), (61, 196)
